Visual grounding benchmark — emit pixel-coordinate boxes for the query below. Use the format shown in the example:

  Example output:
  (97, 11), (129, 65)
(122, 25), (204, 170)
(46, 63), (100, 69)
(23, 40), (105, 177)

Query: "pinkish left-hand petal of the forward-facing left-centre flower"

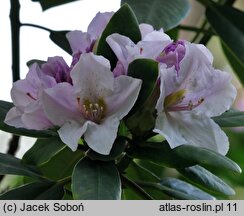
(41, 83), (82, 126)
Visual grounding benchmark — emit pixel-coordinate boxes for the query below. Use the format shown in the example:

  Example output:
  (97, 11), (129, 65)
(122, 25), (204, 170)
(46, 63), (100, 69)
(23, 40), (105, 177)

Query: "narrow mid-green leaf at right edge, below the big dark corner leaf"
(222, 43), (244, 83)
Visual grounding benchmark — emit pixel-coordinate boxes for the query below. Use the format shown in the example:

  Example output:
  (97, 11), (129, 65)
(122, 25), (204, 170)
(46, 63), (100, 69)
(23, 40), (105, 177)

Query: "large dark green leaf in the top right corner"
(206, 3), (244, 63)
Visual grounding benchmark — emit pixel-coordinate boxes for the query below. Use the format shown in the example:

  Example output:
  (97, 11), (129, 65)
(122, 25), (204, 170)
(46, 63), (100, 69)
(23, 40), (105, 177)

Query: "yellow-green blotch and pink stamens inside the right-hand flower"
(164, 89), (204, 112)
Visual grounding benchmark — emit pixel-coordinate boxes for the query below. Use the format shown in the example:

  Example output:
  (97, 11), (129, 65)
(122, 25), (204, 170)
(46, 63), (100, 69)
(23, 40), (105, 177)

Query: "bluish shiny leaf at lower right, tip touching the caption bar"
(157, 178), (215, 200)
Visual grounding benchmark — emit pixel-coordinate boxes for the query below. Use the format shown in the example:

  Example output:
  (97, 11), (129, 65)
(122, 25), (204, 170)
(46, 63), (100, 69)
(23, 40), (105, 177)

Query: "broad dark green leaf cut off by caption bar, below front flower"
(72, 159), (121, 200)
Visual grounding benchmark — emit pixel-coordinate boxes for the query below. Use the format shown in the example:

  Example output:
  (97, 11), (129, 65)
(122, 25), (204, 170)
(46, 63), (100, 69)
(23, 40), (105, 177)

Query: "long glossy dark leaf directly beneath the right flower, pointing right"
(128, 142), (241, 173)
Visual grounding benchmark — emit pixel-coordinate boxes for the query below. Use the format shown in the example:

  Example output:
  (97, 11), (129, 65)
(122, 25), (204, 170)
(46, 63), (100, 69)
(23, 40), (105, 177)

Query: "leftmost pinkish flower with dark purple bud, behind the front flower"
(4, 57), (71, 130)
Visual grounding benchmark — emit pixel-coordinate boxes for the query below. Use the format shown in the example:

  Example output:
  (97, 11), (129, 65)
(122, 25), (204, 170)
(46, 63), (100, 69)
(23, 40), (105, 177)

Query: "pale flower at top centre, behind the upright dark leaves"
(106, 24), (172, 76)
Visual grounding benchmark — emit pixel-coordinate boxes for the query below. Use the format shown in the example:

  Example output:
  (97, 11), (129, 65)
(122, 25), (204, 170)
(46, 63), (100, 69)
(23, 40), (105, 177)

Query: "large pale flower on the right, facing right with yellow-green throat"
(154, 42), (236, 155)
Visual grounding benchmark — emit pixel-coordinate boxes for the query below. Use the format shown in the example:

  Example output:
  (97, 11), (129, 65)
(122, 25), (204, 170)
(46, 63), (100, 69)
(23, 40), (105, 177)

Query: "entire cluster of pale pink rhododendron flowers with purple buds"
(5, 13), (236, 155)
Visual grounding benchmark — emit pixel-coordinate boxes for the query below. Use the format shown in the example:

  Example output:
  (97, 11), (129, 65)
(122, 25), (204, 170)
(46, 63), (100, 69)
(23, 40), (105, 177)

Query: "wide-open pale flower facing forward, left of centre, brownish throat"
(42, 53), (141, 155)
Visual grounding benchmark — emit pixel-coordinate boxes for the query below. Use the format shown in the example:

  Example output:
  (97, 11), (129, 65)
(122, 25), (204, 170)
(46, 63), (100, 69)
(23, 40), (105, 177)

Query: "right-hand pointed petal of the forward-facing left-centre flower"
(105, 75), (142, 120)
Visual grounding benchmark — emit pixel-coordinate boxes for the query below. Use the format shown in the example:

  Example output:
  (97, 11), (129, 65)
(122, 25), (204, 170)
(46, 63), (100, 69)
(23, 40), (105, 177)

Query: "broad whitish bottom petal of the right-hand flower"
(154, 111), (229, 155)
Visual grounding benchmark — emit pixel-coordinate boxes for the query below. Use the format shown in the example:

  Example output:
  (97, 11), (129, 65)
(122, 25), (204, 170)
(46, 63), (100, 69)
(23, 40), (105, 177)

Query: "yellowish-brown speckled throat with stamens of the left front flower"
(77, 97), (106, 124)
